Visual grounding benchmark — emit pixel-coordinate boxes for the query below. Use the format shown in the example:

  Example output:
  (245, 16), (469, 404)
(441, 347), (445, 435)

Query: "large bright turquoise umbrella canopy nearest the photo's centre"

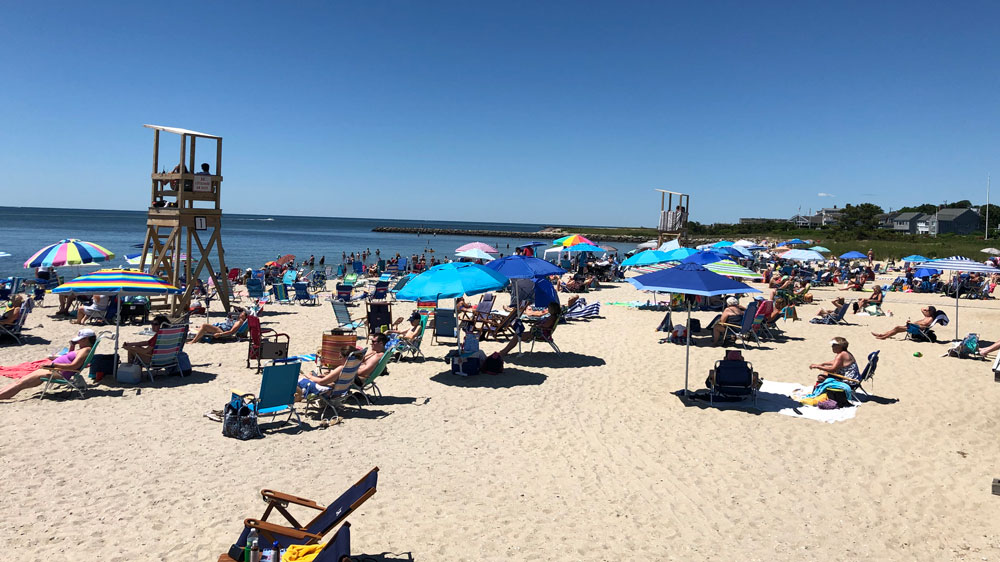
(396, 262), (508, 301)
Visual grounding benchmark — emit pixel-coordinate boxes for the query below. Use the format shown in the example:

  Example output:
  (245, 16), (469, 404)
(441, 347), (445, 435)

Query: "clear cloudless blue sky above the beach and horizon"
(0, 1), (1000, 226)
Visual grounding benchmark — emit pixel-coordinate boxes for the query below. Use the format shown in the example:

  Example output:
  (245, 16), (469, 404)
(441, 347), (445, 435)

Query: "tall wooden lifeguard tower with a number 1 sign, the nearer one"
(139, 125), (230, 317)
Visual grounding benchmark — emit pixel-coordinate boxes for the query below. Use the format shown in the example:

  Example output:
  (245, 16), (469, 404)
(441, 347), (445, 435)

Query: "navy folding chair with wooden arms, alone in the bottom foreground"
(229, 467), (378, 562)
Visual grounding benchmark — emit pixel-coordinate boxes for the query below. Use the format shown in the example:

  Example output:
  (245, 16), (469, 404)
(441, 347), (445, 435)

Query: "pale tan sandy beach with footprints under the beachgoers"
(0, 276), (1000, 562)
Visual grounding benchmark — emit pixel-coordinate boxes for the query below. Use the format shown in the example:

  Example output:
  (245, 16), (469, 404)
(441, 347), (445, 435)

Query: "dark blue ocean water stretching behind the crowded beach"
(0, 207), (564, 277)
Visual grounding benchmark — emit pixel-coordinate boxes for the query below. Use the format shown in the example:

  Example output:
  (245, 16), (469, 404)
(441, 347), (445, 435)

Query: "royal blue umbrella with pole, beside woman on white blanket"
(628, 263), (760, 396)
